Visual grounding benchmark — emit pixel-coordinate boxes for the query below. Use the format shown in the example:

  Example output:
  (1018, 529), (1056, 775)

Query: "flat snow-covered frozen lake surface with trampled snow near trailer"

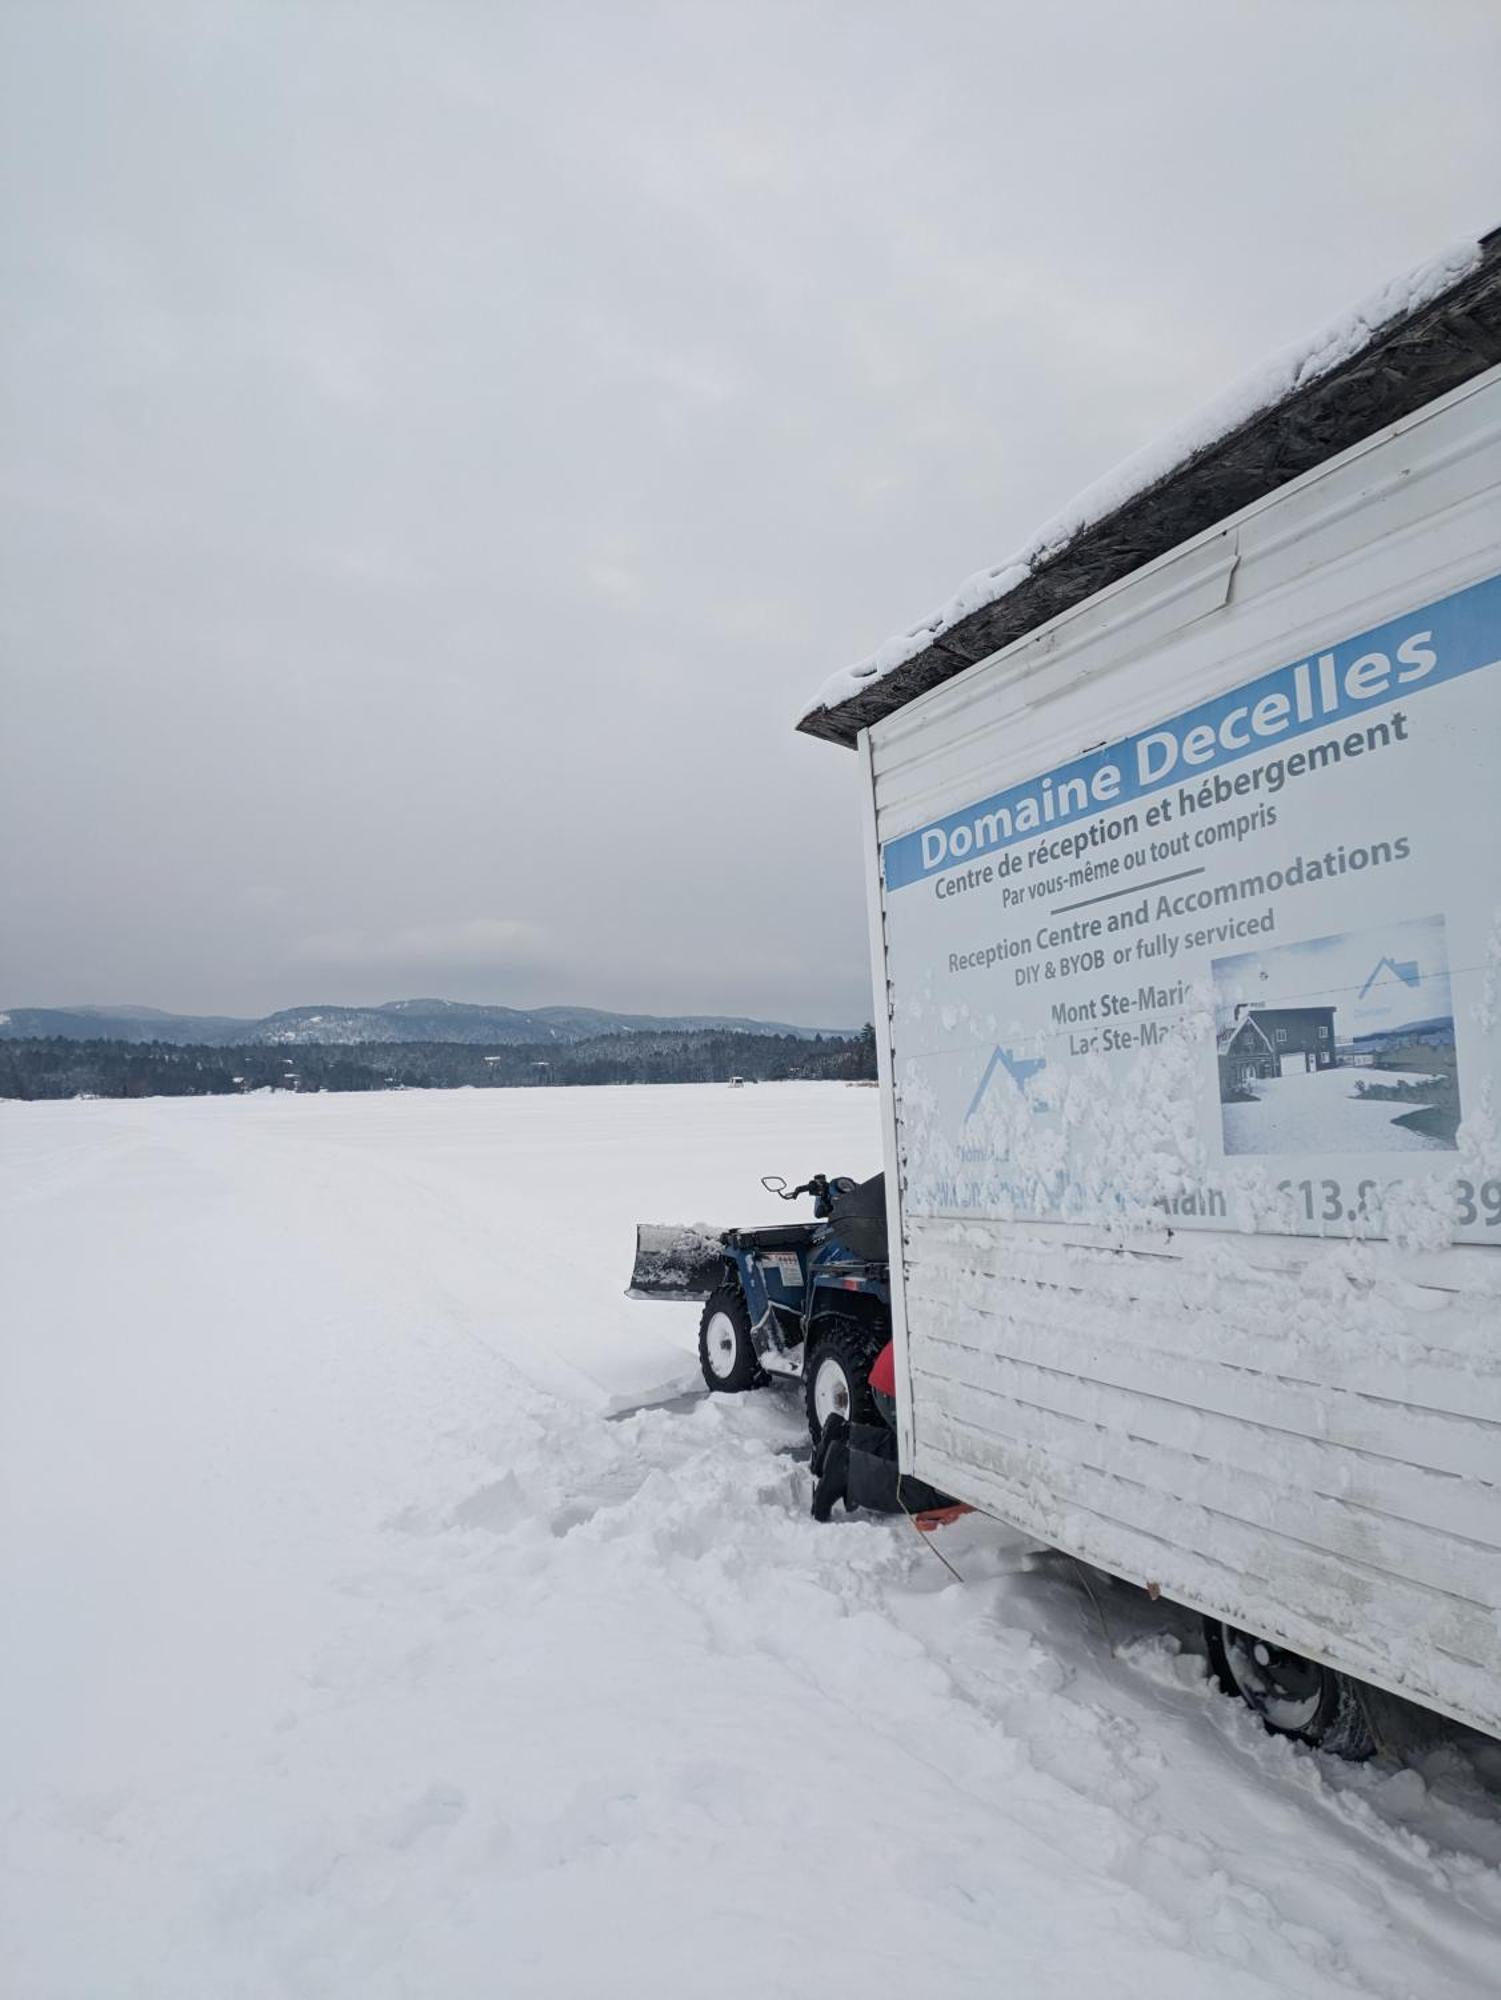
(0, 1084), (1501, 2000)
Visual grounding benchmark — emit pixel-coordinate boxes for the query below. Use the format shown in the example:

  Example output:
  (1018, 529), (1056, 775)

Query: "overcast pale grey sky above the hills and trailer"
(0, 0), (1501, 1022)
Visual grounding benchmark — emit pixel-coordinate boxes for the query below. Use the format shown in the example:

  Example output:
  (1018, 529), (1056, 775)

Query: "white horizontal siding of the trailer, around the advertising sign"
(863, 370), (1501, 1734)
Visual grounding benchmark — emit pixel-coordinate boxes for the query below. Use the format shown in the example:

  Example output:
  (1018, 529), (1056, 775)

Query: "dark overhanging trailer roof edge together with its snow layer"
(799, 230), (1501, 746)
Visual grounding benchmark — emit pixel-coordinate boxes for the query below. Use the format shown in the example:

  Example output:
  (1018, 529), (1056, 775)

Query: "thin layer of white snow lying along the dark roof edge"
(803, 242), (1481, 720)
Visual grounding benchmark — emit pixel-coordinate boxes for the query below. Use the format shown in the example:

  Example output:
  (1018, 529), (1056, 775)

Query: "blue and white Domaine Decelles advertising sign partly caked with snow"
(881, 576), (1501, 1244)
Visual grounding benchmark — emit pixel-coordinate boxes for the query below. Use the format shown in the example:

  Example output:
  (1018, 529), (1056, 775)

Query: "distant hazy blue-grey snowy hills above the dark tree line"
(0, 1000), (855, 1046)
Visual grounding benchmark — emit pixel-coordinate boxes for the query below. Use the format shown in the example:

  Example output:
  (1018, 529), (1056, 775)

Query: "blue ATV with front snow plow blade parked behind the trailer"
(628, 1174), (891, 1444)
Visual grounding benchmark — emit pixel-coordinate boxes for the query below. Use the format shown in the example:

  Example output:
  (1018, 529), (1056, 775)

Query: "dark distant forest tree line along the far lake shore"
(0, 1026), (877, 1098)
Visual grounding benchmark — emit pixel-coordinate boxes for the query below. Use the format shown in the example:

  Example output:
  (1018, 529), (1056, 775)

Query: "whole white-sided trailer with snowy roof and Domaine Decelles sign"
(803, 236), (1501, 1736)
